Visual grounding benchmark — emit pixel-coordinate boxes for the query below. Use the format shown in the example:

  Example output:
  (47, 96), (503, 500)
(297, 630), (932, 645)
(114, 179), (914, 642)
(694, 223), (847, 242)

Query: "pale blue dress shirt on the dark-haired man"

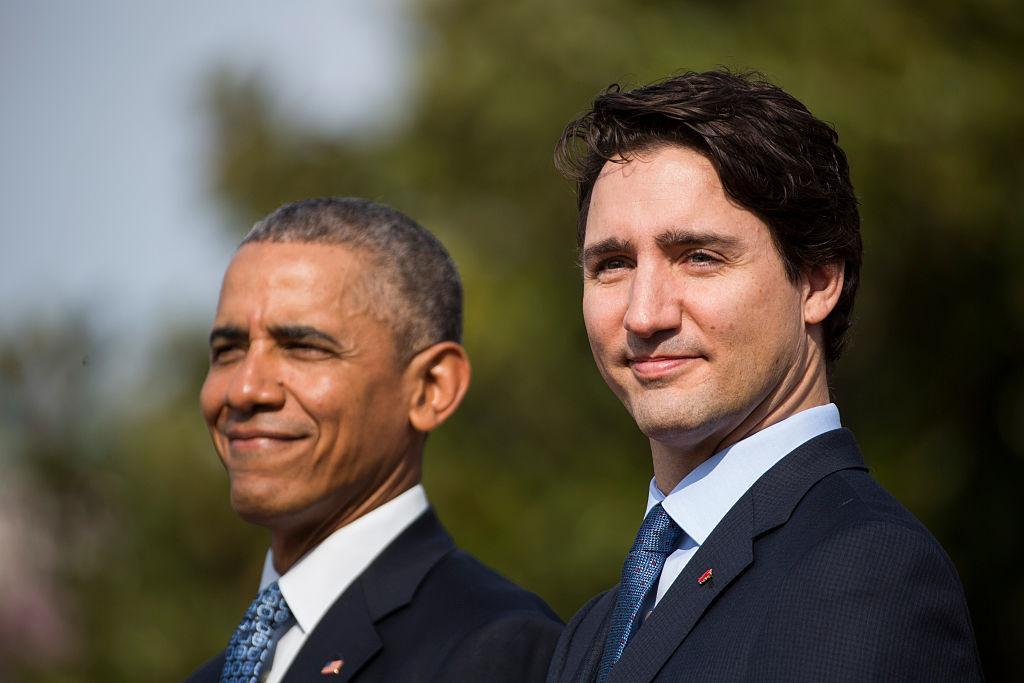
(644, 403), (842, 605)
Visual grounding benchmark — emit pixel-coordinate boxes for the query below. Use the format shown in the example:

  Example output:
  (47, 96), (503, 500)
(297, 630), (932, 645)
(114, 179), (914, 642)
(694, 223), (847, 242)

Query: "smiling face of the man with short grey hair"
(200, 243), (422, 527)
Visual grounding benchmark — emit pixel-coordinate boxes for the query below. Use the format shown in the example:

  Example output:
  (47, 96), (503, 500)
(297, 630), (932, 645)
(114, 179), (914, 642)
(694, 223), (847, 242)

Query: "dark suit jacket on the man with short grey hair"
(188, 510), (562, 683)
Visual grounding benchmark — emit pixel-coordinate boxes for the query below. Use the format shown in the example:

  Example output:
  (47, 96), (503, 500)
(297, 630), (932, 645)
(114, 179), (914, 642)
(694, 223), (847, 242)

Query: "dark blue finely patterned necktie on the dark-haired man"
(597, 503), (683, 683)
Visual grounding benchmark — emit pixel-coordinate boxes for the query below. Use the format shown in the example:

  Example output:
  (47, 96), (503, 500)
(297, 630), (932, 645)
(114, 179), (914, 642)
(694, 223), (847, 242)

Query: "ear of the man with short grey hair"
(407, 342), (470, 433)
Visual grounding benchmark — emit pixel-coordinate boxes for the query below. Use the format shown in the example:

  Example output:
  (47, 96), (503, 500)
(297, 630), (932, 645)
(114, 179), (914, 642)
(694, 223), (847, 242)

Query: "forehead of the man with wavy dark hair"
(584, 146), (760, 246)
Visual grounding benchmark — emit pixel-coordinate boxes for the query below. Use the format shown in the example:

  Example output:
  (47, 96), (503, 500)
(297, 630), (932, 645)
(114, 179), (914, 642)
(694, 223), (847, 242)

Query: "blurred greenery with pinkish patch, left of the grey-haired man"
(0, 325), (263, 681)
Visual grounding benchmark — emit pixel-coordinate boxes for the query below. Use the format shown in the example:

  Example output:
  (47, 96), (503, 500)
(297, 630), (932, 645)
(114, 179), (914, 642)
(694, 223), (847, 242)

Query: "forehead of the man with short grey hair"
(217, 243), (372, 323)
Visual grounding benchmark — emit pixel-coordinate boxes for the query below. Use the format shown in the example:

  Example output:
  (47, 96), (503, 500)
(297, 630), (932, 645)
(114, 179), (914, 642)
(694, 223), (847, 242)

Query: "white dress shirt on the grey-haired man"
(259, 484), (429, 683)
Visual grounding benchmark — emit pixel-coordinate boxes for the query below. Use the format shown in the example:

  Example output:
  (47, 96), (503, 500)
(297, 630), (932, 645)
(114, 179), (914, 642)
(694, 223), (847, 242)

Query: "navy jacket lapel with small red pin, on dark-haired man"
(597, 429), (866, 683)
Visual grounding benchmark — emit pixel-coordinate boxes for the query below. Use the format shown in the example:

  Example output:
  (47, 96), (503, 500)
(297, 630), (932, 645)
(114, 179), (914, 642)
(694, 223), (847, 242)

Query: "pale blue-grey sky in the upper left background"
(0, 0), (413, 358)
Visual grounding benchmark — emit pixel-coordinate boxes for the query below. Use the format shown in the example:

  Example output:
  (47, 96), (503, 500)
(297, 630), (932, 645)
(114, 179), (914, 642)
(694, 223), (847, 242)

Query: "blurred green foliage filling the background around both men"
(0, 0), (1024, 681)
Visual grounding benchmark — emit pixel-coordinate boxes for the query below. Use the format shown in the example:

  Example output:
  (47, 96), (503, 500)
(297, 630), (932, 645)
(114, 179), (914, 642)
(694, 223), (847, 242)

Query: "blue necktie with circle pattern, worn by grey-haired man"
(220, 582), (292, 683)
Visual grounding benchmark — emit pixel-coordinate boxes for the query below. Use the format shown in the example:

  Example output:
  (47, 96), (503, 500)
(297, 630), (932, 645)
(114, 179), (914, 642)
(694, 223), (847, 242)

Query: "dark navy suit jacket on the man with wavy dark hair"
(548, 429), (982, 683)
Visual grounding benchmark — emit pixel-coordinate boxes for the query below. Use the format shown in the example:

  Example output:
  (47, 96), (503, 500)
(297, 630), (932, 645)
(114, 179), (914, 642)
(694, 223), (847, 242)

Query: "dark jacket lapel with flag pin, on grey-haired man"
(283, 509), (455, 683)
